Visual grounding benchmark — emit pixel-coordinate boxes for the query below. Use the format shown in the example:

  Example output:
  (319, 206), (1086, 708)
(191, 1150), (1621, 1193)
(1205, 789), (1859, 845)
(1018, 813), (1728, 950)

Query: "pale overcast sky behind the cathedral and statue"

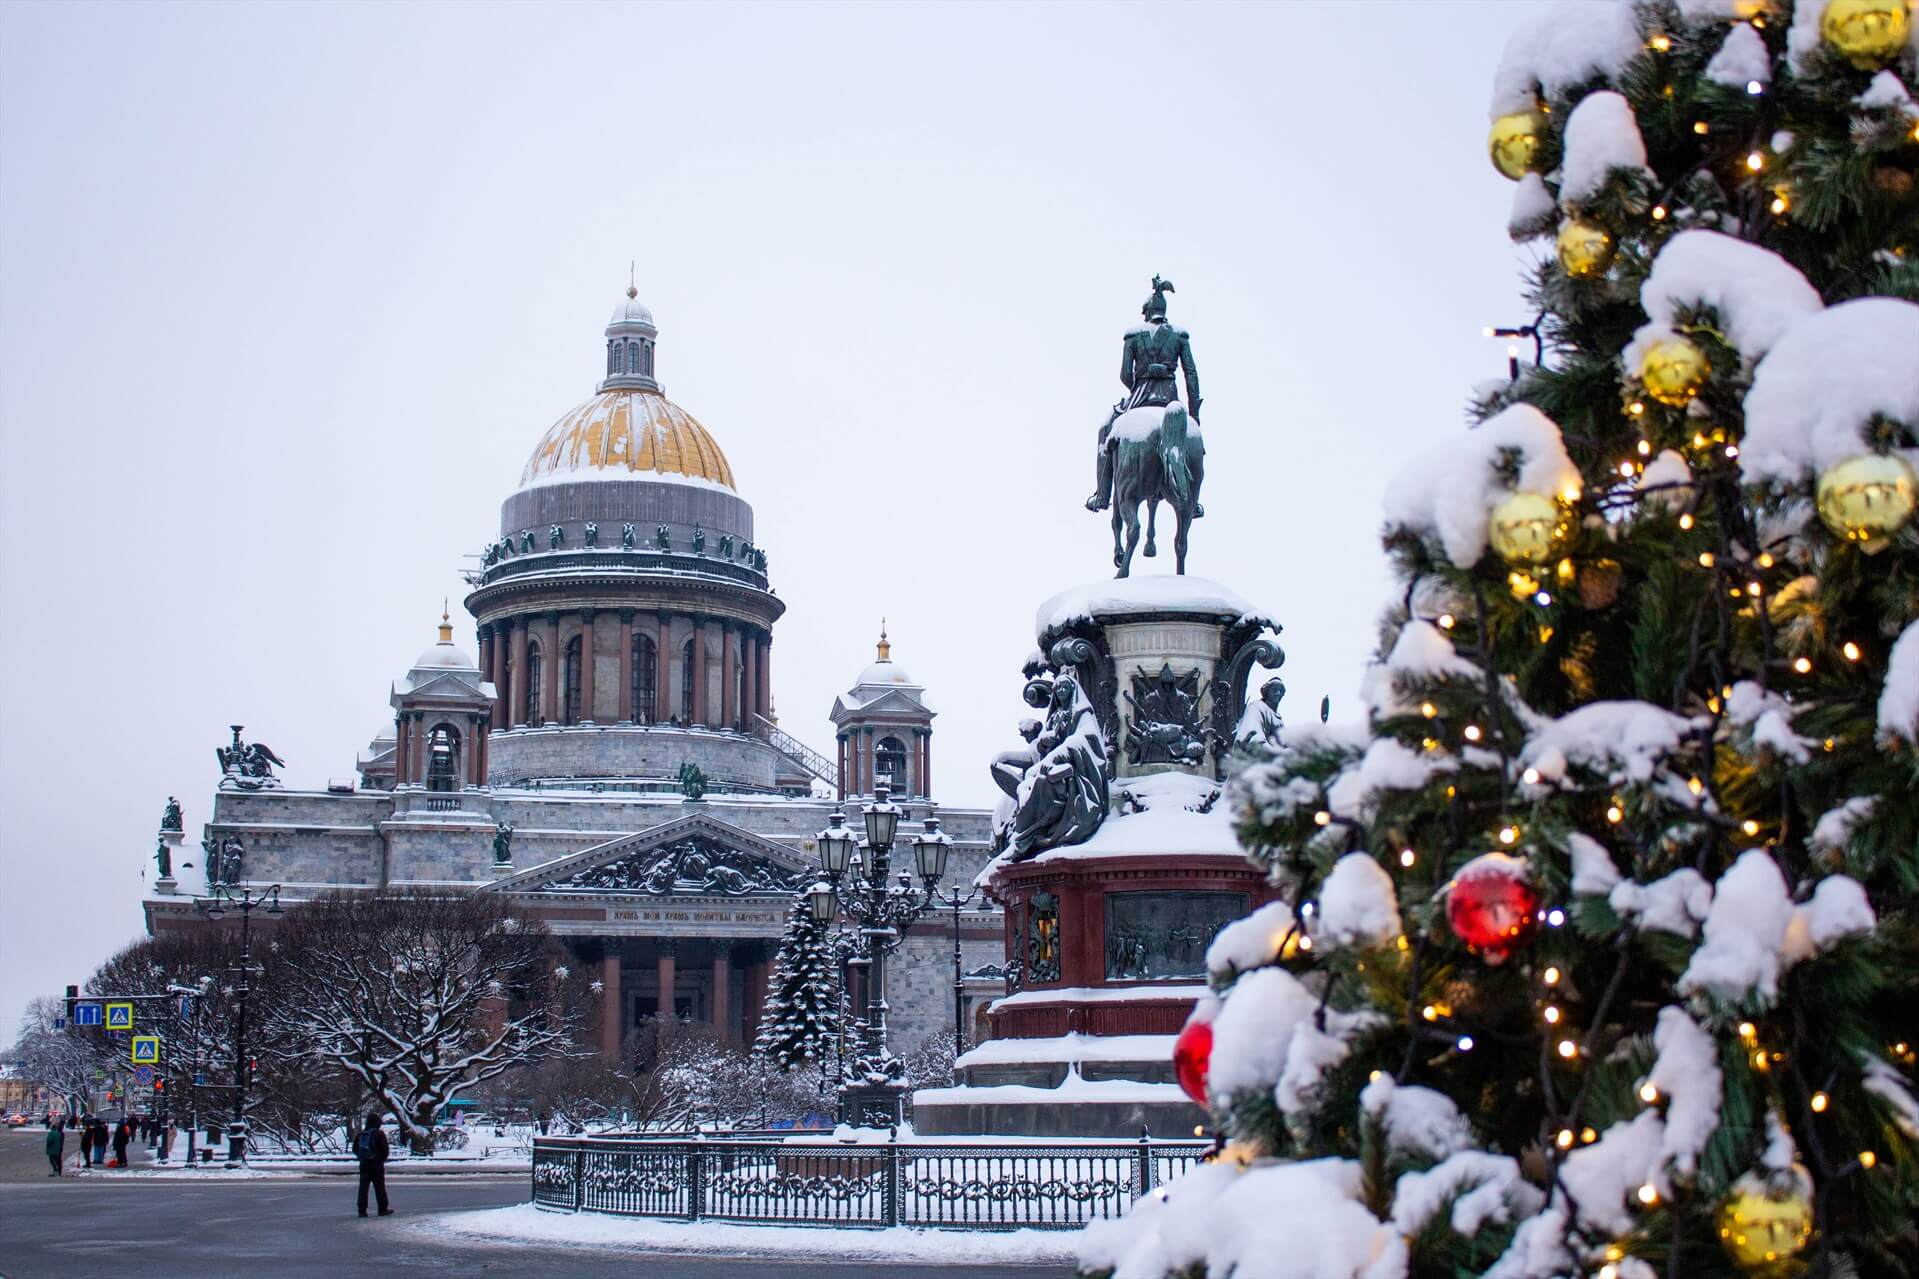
(0, 0), (1531, 1041)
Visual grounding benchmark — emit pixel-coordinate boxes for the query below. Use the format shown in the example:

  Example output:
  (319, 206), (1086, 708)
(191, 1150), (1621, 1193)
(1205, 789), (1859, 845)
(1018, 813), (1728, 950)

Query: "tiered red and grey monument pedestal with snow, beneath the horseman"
(913, 578), (1284, 1139)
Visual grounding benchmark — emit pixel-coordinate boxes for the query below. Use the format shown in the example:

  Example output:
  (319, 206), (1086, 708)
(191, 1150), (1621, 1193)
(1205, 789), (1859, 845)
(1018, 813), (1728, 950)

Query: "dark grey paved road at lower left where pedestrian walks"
(0, 1131), (1063, 1279)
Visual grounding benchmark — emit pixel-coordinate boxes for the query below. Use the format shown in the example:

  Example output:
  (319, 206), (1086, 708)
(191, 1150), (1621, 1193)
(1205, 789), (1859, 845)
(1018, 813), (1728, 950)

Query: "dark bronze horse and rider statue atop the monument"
(1086, 275), (1205, 578)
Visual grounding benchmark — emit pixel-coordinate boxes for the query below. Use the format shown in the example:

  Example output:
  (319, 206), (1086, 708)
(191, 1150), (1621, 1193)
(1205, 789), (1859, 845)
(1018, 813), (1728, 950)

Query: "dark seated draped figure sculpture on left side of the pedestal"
(994, 674), (1109, 860)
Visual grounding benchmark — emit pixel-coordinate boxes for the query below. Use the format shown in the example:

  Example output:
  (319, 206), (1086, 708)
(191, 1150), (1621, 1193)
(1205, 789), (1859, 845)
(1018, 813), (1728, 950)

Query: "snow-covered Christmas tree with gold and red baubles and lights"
(1082, 0), (1919, 1279)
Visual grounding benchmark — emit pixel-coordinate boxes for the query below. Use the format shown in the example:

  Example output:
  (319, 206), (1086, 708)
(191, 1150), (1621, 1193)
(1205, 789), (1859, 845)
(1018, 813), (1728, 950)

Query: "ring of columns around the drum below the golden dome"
(480, 607), (773, 730)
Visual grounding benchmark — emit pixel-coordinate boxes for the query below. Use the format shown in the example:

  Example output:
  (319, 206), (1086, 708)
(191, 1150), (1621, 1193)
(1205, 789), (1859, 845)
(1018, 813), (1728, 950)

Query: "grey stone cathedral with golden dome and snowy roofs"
(146, 290), (1002, 1052)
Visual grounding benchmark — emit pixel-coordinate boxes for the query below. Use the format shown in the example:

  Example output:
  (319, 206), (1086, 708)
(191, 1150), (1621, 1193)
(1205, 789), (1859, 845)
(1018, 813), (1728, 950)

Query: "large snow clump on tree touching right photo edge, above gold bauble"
(1742, 295), (1919, 484)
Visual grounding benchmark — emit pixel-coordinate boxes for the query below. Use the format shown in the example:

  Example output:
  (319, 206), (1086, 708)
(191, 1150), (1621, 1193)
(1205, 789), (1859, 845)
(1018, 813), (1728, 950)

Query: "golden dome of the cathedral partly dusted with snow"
(520, 388), (733, 490)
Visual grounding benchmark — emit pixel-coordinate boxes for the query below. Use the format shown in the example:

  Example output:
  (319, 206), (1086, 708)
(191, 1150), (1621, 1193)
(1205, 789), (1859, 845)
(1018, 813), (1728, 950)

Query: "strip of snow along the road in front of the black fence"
(416, 1204), (1078, 1266)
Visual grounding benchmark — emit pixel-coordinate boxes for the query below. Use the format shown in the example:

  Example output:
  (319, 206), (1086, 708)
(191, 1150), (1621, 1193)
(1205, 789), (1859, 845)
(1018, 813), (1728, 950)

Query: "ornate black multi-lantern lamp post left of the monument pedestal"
(808, 785), (952, 1127)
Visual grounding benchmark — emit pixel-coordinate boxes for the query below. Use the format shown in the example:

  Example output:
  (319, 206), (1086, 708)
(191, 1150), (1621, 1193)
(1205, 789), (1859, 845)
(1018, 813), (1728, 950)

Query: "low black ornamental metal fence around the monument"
(533, 1135), (1211, 1231)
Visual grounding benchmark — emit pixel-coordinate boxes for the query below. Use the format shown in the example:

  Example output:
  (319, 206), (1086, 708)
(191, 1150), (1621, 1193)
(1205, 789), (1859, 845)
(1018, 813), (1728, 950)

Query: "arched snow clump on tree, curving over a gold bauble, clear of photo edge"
(1620, 230), (1823, 373)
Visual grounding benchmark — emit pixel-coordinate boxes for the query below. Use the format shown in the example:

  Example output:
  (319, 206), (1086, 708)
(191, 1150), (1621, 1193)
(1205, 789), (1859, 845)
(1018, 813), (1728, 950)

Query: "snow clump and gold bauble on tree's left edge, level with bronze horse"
(1386, 403), (1579, 568)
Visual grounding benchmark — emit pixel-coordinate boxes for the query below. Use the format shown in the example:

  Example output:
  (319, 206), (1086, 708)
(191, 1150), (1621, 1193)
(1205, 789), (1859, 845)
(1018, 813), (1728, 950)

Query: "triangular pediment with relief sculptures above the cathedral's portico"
(489, 812), (817, 899)
